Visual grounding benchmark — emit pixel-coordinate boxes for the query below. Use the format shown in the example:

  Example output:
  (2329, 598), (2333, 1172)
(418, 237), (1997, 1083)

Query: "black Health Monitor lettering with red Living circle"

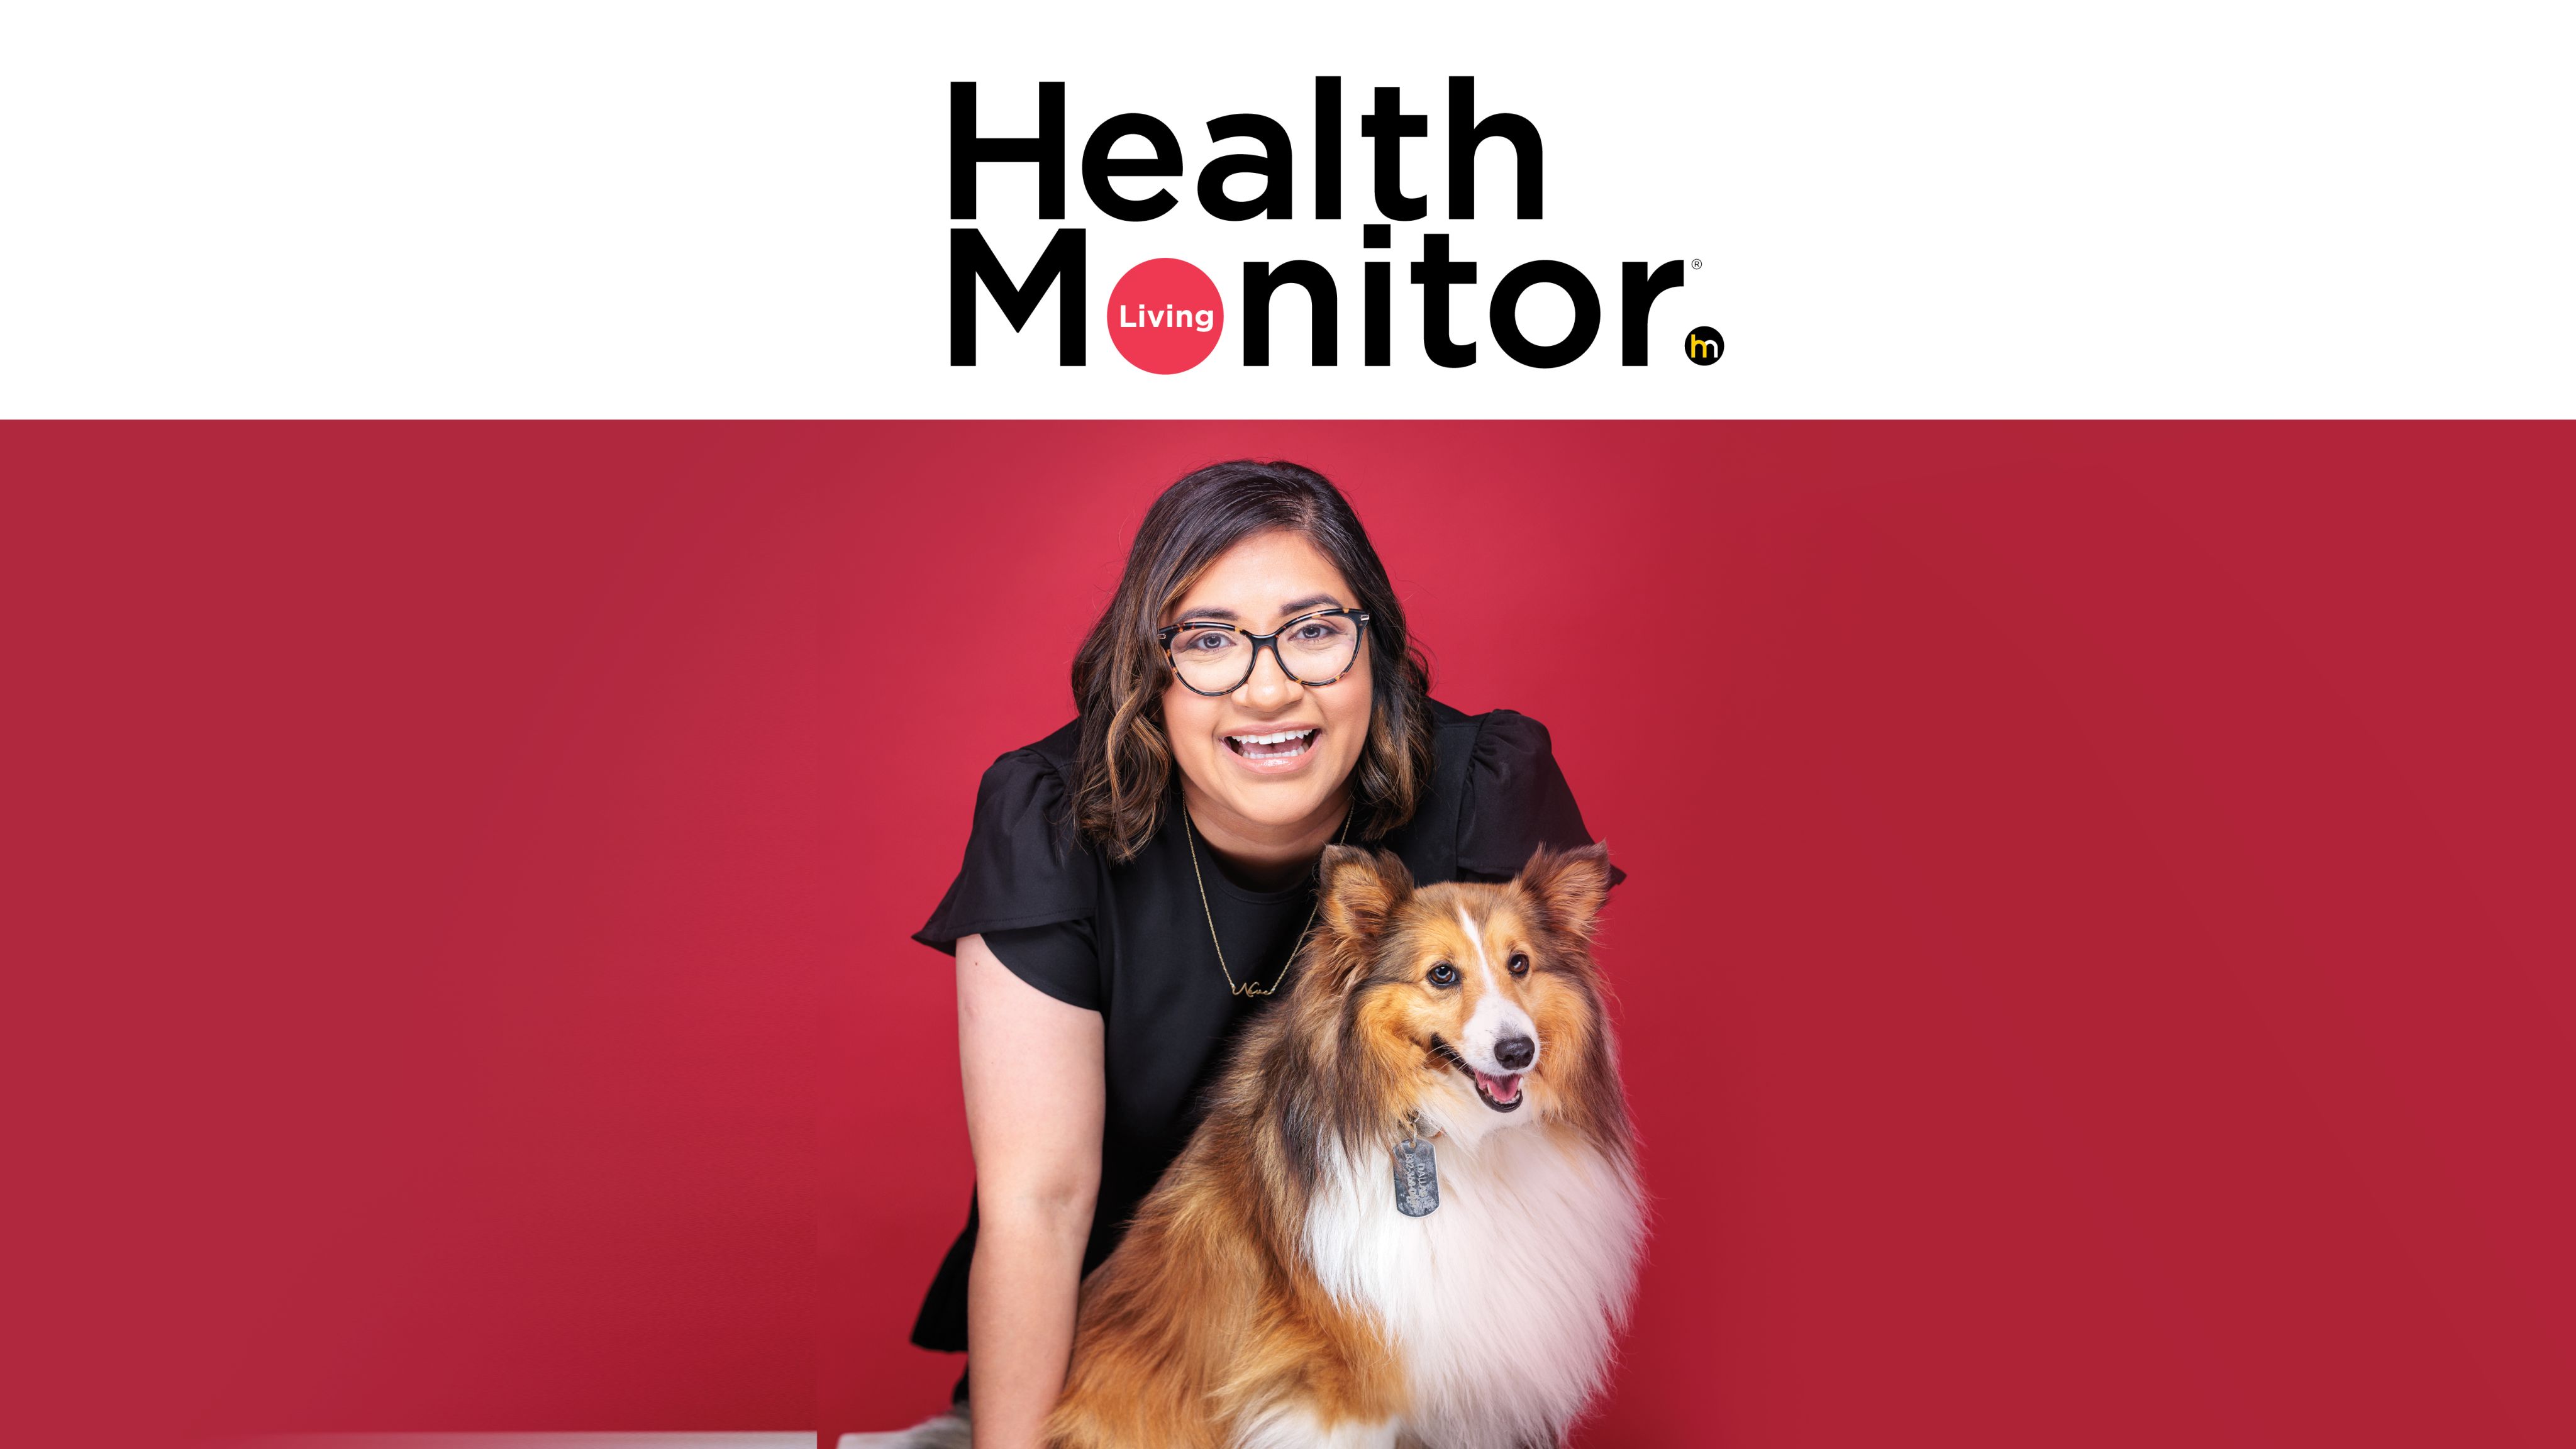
(948, 75), (1726, 374)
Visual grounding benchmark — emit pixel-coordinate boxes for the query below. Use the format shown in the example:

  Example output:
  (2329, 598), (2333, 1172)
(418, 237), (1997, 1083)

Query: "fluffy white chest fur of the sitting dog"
(1306, 1124), (1643, 1449)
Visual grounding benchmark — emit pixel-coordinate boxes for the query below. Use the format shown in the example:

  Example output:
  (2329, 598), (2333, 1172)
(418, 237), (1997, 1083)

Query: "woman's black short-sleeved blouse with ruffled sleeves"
(912, 701), (1620, 1351)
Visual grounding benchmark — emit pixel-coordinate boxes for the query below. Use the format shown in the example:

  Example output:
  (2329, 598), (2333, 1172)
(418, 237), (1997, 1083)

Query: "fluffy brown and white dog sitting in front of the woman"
(1046, 846), (1643, 1449)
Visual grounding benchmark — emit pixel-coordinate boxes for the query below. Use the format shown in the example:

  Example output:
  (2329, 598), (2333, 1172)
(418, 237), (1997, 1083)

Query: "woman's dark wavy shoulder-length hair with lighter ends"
(1072, 462), (1432, 861)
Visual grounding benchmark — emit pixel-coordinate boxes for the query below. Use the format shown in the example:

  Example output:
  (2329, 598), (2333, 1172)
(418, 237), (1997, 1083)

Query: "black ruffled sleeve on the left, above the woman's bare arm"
(912, 750), (1100, 954)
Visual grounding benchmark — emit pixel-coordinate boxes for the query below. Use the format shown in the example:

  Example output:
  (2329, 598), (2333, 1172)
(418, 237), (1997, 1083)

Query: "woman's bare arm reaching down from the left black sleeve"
(958, 936), (1108, 1449)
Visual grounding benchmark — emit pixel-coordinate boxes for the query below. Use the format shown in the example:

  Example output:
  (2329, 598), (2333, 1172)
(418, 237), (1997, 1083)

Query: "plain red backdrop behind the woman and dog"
(0, 423), (2576, 1446)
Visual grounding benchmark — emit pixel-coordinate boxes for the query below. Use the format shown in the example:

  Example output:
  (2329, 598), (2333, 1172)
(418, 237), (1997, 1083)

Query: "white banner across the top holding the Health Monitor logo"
(0, 0), (2576, 418)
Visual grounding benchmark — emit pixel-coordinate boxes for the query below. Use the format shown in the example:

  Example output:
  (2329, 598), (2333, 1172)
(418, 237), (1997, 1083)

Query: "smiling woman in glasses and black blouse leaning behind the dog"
(912, 462), (1618, 1449)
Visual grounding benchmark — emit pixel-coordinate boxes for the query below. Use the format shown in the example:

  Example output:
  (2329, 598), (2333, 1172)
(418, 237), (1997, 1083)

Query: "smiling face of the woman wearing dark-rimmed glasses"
(1162, 531), (1373, 840)
